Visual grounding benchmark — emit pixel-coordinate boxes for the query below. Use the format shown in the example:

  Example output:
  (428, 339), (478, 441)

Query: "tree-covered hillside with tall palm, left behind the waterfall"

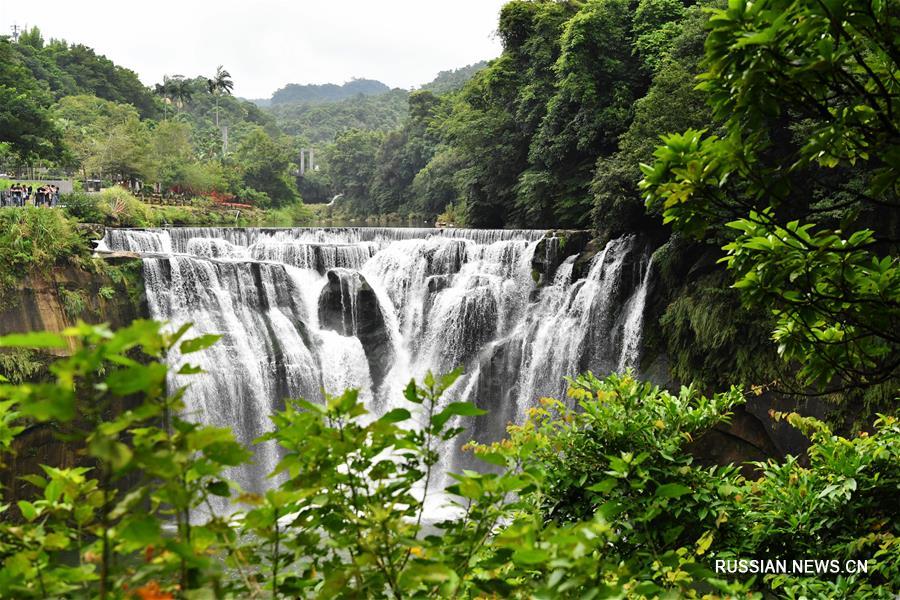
(0, 27), (299, 213)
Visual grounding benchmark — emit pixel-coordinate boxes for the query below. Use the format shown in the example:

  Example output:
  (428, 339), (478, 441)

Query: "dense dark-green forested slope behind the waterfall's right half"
(316, 0), (709, 228)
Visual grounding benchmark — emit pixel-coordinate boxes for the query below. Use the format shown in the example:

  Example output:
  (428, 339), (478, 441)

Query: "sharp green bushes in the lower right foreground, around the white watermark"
(506, 375), (900, 598)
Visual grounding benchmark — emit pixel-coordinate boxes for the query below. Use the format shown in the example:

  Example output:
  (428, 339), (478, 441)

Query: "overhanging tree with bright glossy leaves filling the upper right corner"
(643, 0), (900, 398)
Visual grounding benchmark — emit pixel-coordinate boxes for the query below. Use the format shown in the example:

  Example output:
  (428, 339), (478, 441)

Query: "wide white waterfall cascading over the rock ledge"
(99, 228), (651, 489)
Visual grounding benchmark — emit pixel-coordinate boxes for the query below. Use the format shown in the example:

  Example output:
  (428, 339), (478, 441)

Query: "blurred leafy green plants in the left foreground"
(0, 321), (249, 598)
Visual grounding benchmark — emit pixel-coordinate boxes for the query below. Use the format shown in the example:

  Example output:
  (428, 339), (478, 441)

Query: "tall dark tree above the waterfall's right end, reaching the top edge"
(517, 0), (648, 227)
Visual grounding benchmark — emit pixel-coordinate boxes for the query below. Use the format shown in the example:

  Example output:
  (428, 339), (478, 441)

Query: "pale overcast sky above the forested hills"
(0, 0), (505, 98)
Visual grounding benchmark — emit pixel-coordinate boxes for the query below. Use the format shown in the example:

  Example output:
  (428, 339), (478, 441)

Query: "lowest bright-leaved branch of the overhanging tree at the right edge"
(725, 212), (900, 385)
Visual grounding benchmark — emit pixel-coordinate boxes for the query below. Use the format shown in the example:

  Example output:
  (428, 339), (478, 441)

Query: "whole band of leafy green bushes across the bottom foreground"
(0, 321), (900, 598)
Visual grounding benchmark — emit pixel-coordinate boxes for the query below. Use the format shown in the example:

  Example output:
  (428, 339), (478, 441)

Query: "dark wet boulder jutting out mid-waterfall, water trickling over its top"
(319, 269), (394, 388)
